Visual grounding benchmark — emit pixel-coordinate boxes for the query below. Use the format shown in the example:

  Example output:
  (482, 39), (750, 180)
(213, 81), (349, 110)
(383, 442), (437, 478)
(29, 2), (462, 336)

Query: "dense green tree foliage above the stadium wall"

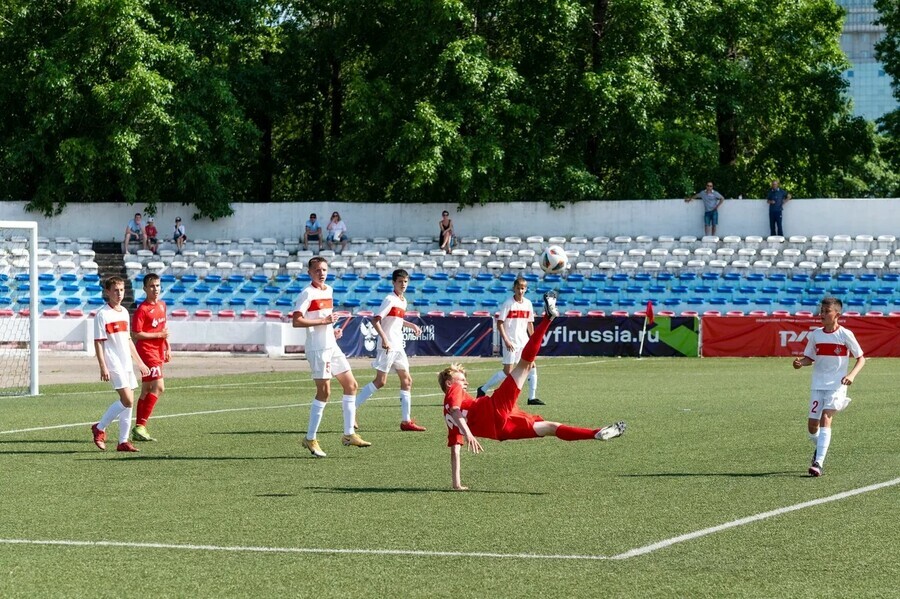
(0, 0), (900, 218)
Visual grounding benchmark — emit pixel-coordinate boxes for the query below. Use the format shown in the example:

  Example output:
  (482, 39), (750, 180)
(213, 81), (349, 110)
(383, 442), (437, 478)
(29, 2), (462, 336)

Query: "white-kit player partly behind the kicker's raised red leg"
(476, 277), (544, 406)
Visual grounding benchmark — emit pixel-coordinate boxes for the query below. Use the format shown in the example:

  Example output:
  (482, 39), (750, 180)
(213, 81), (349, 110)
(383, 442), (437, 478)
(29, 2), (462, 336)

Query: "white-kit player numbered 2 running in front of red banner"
(793, 297), (866, 476)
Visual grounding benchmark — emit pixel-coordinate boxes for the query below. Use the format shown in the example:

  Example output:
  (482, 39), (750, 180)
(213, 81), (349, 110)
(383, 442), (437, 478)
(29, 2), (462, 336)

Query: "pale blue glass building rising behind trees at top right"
(836, 0), (898, 120)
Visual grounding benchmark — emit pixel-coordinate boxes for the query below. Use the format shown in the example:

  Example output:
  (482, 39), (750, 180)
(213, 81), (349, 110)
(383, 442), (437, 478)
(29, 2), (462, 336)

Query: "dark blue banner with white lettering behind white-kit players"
(336, 316), (494, 358)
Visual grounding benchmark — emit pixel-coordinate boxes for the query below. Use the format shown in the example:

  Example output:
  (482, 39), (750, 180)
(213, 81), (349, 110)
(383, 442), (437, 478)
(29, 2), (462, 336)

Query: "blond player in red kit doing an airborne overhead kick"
(438, 291), (625, 491)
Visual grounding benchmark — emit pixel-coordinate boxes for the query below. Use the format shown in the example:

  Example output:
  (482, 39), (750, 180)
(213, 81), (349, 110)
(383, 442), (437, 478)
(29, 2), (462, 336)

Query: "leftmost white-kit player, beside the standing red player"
(91, 277), (150, 452)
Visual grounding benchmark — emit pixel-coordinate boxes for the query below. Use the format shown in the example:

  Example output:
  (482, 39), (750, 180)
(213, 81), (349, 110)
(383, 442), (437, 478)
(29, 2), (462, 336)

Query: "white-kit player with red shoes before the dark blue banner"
(356, 268), (425, 431)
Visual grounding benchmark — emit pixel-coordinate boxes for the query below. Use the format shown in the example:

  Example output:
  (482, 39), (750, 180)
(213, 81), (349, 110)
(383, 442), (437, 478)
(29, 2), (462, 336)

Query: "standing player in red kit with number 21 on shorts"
(131, 273), (172, 441)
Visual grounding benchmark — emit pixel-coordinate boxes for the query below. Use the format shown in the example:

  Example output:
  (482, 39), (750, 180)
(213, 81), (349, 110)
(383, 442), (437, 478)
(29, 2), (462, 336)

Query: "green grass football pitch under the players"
(0, 358), (900, 598)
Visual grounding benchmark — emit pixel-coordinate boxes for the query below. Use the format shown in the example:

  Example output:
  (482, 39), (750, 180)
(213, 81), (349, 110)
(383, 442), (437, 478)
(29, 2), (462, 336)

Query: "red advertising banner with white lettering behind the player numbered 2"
(700, 316), (900, 358)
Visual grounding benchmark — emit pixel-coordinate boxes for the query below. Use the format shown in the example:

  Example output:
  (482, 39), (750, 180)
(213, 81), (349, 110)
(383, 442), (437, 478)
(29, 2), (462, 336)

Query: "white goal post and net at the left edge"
(0, 220), (40, 396)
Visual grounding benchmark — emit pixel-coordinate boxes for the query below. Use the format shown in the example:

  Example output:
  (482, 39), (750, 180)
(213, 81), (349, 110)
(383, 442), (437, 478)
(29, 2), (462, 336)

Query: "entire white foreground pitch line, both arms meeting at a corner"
(0, 478), (900, 561)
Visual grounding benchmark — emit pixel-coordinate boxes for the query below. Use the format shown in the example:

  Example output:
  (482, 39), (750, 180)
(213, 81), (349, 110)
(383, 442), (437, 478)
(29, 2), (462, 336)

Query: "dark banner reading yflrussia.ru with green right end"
(541, 316), (700, 357)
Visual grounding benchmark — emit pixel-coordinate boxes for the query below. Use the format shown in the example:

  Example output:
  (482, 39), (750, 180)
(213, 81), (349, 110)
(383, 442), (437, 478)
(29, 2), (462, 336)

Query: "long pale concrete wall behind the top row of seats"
(0, 199), (900, 241)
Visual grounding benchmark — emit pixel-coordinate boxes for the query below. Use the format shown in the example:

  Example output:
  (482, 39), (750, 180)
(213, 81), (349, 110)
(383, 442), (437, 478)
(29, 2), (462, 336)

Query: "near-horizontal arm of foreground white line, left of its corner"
(0, 539), (609, 560)
